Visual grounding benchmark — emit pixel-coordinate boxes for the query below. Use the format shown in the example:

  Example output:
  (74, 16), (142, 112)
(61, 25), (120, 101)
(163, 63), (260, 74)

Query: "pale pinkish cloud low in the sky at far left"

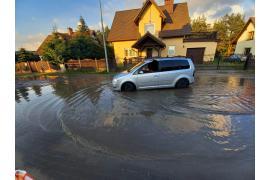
(15, 32), (46, 51)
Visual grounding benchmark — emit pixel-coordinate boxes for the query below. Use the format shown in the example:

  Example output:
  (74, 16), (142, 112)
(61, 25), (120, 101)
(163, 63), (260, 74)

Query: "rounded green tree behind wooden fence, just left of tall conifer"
(42, 33), (66, 65)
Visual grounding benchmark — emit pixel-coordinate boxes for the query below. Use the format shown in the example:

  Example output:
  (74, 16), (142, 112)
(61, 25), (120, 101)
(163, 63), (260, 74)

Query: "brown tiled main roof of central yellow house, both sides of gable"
(108, 3), (191, 42)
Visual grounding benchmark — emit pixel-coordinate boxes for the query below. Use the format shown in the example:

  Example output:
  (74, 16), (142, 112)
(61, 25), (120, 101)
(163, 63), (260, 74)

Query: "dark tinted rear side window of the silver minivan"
(159, 59), (190, 72)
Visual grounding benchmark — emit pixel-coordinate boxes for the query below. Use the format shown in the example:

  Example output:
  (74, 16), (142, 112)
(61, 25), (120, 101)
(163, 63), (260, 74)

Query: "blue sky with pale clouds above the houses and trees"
(15, 0), (255, 51)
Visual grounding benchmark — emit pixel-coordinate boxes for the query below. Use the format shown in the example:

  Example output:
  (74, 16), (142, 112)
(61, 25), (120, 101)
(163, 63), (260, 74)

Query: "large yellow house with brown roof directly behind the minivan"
(108, 0), (217, 63)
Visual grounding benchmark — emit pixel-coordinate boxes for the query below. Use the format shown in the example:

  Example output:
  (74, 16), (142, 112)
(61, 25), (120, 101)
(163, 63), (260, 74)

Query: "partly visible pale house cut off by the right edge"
(233, 17), (255, 55)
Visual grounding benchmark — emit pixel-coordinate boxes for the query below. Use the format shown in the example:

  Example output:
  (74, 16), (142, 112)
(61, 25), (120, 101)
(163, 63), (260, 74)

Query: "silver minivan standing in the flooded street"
(112, 57), (195, 91)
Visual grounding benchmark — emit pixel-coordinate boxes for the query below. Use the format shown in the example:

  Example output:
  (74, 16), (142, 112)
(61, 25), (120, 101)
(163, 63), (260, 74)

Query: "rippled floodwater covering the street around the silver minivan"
(15, 71), (255, 180)
